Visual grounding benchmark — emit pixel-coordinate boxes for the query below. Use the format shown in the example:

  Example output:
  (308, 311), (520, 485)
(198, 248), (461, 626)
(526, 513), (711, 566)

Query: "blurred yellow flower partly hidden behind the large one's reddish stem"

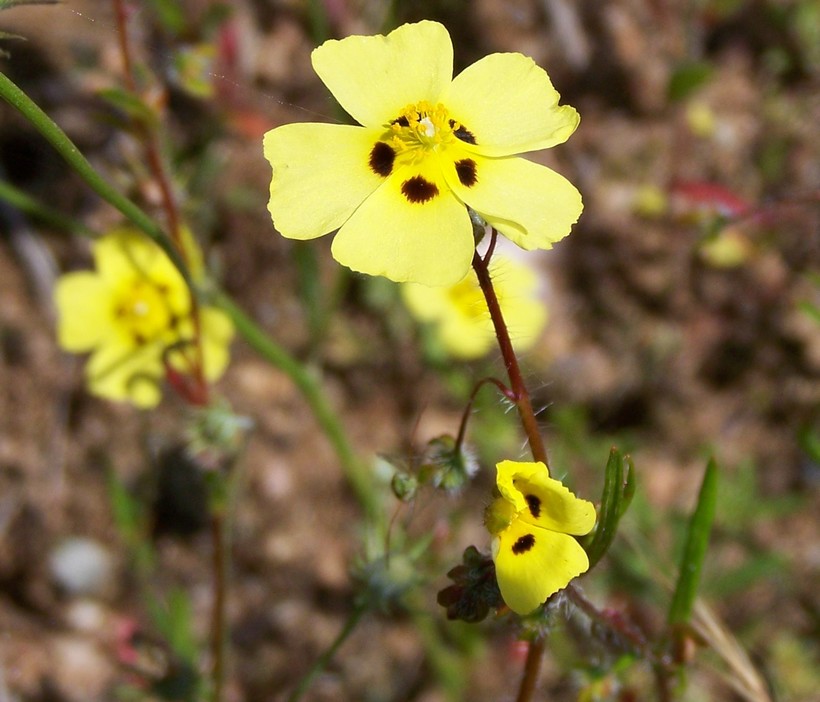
(402, 254), (547, 359)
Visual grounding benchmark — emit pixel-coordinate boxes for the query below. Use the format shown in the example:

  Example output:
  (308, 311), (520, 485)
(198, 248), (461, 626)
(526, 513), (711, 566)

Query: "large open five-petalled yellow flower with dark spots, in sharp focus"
(264, 21), (582, 285)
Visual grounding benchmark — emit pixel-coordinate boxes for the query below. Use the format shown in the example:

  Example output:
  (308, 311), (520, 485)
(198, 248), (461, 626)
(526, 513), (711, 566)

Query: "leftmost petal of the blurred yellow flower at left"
(54, 271), (112, 353)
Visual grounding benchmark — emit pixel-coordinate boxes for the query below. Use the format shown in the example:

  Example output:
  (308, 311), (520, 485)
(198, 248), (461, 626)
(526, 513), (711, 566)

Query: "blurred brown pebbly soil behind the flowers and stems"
(0, 0), (820, 702)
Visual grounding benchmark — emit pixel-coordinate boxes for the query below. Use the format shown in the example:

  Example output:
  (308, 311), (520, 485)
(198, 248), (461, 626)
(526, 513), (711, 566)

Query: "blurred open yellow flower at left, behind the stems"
(54, 228), (233, 407)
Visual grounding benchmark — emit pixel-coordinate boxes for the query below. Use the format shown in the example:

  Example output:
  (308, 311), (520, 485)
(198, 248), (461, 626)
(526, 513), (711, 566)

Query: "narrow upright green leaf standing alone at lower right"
(669, 459), (718, 626)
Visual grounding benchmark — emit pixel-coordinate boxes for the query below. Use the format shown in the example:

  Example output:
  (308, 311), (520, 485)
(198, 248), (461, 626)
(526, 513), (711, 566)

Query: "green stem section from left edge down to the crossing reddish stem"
(0, 72), (191, 284)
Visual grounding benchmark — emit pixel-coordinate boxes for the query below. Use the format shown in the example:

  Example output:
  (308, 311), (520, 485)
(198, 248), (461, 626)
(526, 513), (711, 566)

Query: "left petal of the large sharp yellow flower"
(264, 124), (384, 245)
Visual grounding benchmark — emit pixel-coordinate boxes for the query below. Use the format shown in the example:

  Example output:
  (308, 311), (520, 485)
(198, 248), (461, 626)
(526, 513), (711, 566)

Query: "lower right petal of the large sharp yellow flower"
(445, 156), (583, 251)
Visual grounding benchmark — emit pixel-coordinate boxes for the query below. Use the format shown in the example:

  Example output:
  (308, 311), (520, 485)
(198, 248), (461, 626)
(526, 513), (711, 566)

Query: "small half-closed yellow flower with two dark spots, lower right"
(484, 461), (595, 614)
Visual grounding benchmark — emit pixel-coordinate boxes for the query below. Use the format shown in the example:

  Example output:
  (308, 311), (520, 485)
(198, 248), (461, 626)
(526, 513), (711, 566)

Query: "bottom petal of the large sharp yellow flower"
(331, 163), (474, 285)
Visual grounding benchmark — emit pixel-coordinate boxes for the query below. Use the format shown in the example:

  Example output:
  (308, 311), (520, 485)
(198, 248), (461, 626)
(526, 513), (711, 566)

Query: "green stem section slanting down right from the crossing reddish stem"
(214, 293), (379, 517)
